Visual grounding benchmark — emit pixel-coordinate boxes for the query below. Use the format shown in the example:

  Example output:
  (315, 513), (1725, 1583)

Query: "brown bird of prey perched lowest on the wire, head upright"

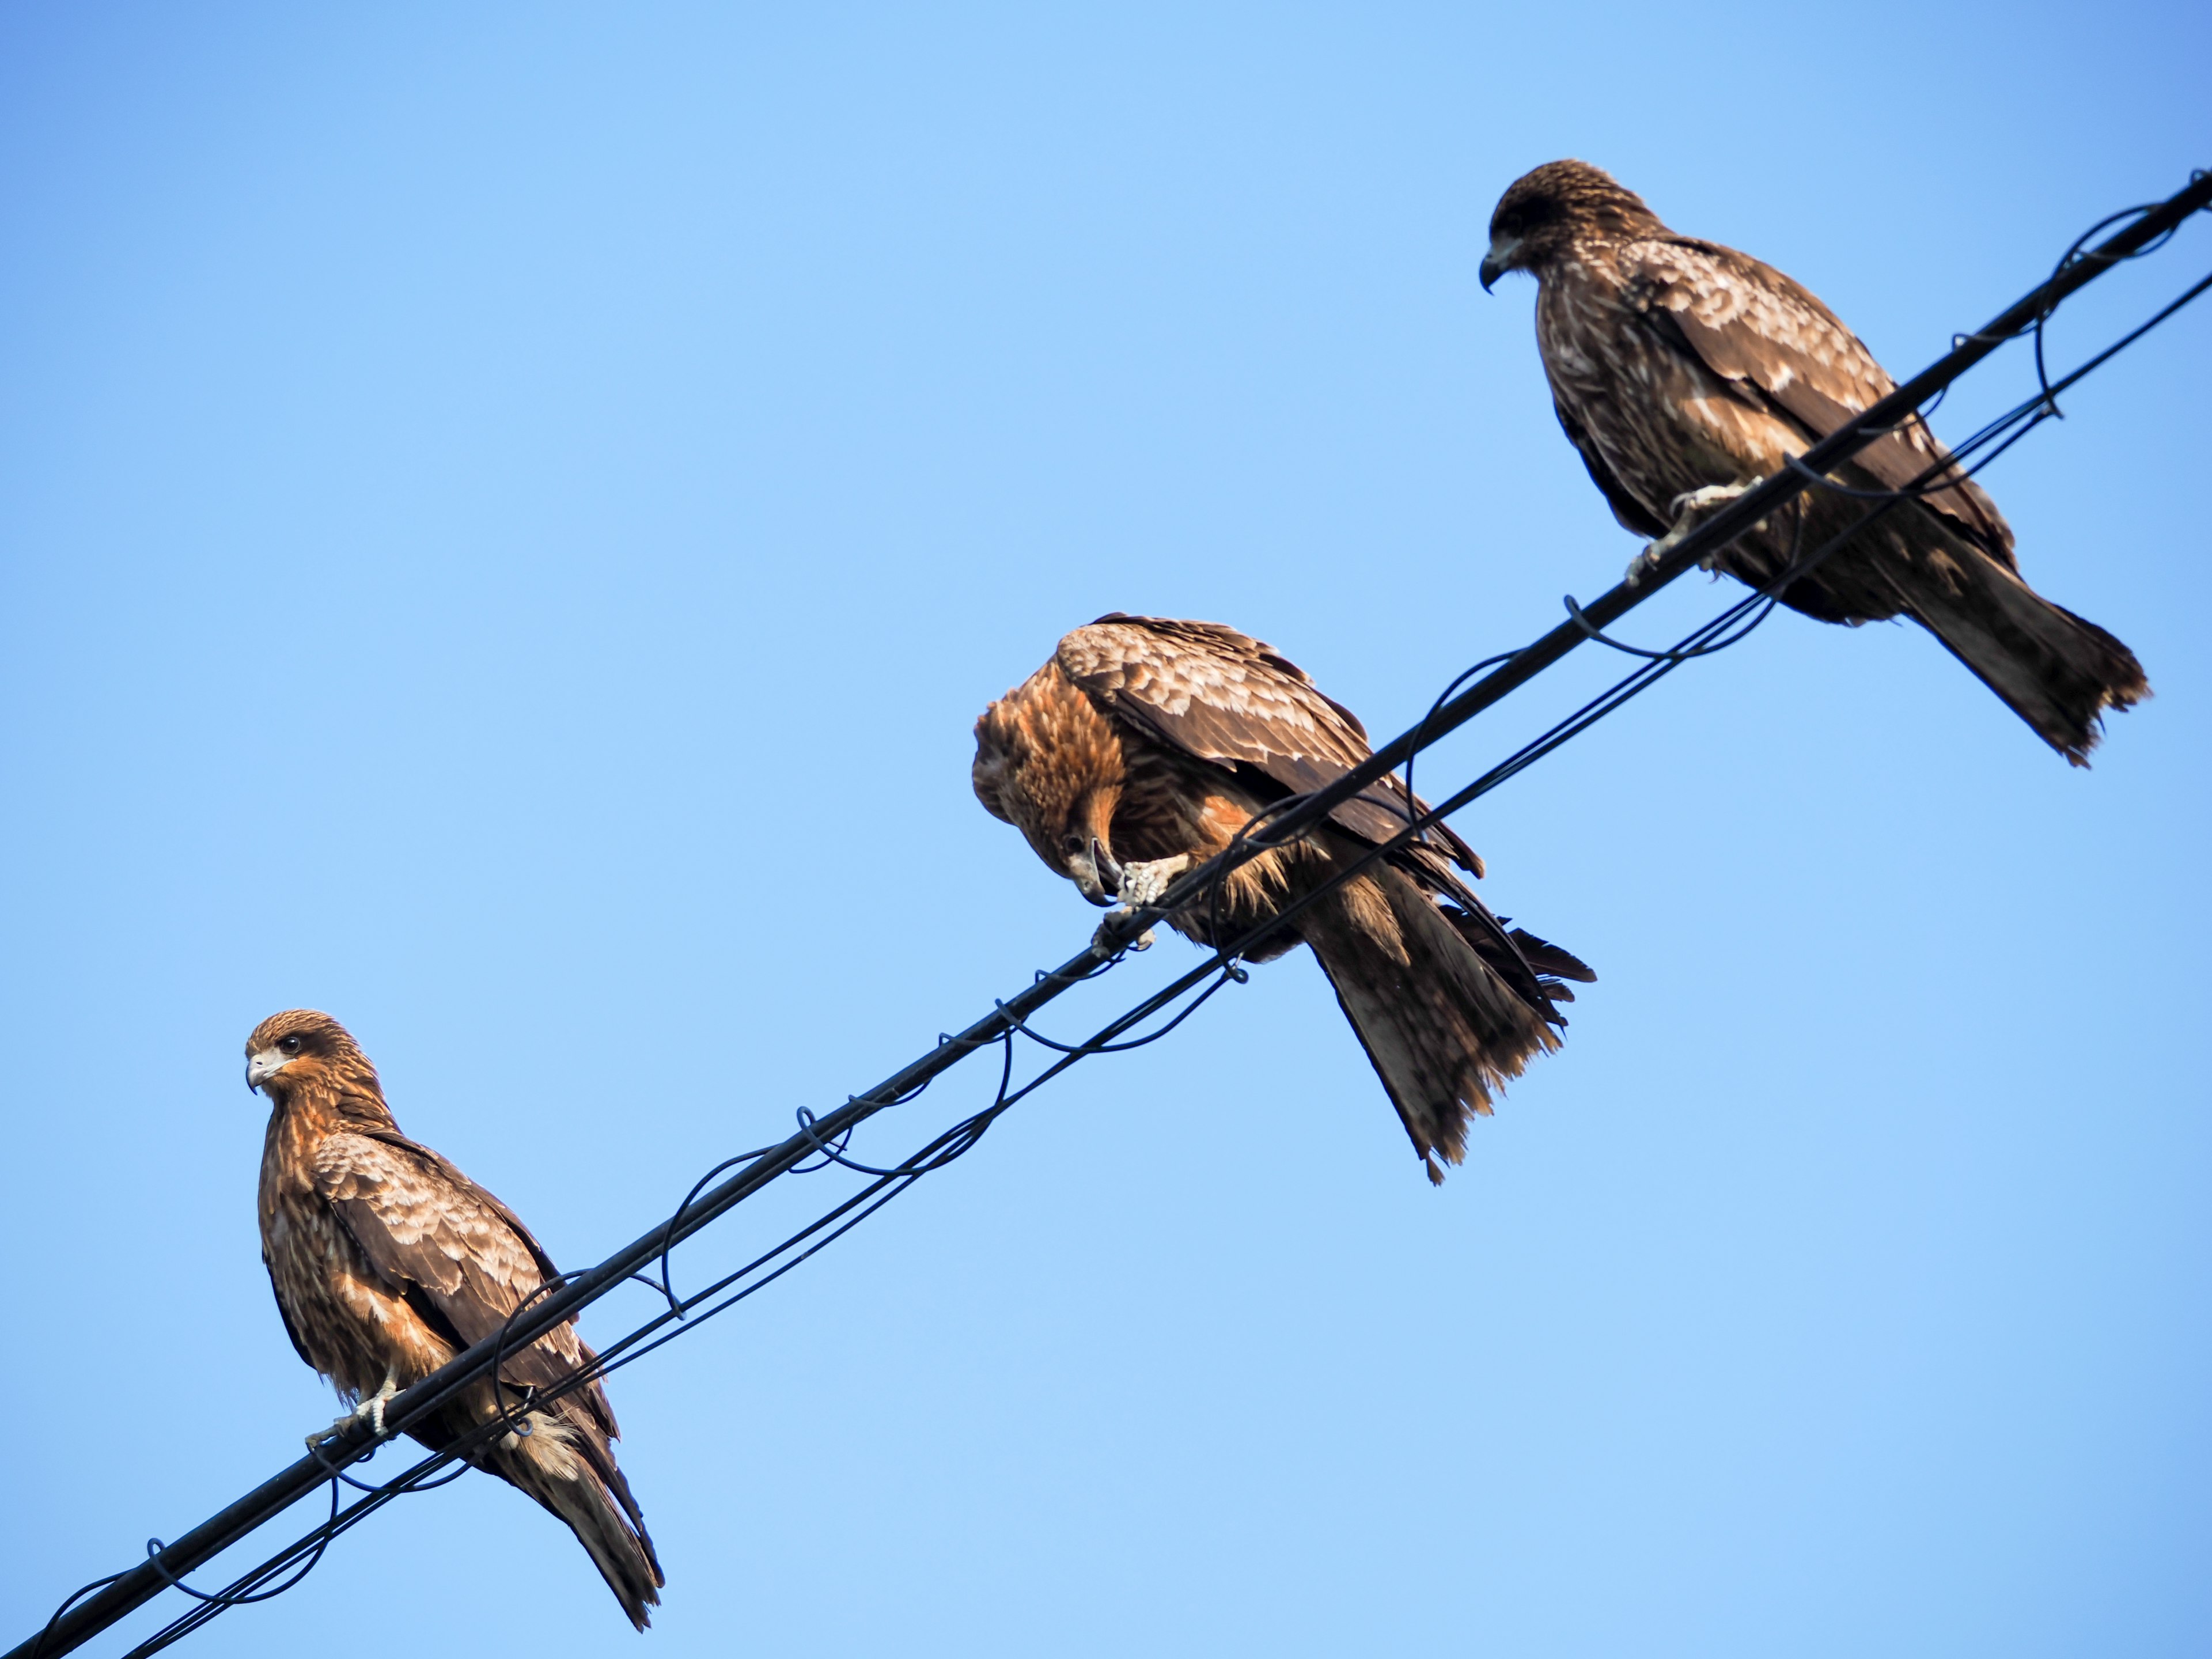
(245, 1009), (666, 1630)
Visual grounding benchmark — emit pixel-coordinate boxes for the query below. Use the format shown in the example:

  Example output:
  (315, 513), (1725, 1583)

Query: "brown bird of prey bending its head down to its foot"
(974, 613), (1597, 1181)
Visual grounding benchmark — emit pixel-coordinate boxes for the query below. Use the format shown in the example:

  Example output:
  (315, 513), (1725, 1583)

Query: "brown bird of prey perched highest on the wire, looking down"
(1482, 161), (2150, 766)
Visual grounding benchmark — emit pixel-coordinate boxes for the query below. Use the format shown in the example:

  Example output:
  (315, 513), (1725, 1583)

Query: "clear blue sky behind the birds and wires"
(0, 0), (2212, 1659)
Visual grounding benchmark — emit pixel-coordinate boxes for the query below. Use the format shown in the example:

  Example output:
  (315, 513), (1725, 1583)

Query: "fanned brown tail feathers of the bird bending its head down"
(1301, 865), (1595, 1183)
